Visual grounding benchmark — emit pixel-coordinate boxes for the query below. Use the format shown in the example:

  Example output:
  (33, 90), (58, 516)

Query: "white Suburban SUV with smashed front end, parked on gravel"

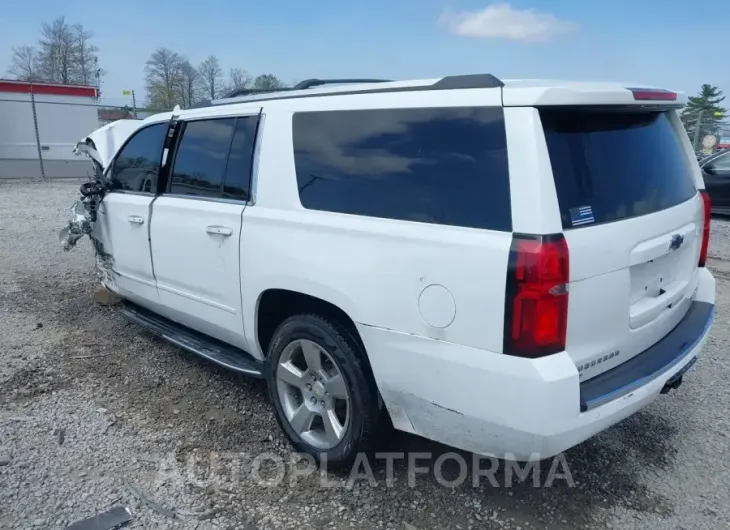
(67, 75), (715, 465)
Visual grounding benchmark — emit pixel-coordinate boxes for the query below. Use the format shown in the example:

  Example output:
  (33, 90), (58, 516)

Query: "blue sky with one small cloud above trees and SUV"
(0, 0), (730, 106)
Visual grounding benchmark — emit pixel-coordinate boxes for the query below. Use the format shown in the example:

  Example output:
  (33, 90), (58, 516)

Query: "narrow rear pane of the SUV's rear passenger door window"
(223, 116), (259, 201)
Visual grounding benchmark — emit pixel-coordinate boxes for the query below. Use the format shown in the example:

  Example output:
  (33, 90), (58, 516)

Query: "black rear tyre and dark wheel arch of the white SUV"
(256, 289), (392, 468)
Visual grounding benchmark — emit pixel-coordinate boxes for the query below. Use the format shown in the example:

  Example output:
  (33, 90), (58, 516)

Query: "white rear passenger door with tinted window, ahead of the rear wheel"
(150, 114), (258, 347)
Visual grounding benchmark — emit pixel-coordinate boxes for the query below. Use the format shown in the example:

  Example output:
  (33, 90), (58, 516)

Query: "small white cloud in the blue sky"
(439, 4), (577, 42)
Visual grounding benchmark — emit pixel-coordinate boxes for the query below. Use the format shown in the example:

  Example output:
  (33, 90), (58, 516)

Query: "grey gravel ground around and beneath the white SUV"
(0, 182), (730, 530)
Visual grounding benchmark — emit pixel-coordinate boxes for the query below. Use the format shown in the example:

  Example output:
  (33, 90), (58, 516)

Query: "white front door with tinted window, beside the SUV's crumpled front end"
(94, 122), (168, 305)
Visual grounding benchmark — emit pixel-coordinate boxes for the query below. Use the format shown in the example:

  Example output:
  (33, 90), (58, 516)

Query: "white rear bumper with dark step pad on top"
(358, 269), (715, 460)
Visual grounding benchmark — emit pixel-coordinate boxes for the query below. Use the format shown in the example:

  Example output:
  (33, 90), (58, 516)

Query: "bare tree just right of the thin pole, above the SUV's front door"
(145, 48), (186, 109)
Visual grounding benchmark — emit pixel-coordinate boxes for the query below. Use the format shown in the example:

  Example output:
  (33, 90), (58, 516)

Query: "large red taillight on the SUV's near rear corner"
(503, 234), (570, 358)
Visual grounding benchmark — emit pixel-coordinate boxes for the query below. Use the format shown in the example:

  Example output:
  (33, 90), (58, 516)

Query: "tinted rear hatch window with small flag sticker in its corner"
(540, 108), (696, 229)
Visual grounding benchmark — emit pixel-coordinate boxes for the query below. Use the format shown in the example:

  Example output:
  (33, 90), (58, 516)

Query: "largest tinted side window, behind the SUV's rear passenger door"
(293, 107), (512, 231)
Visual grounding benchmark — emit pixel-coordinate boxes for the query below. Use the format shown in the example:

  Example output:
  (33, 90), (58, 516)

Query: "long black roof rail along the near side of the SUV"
(193, 74), (504, 108)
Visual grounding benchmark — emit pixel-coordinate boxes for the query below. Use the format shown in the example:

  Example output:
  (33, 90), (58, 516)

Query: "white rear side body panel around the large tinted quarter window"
(241, 89), (511, 358)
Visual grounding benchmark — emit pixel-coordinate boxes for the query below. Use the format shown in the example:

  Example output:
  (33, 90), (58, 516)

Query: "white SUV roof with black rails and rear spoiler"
(145, 74), (686, 121)
